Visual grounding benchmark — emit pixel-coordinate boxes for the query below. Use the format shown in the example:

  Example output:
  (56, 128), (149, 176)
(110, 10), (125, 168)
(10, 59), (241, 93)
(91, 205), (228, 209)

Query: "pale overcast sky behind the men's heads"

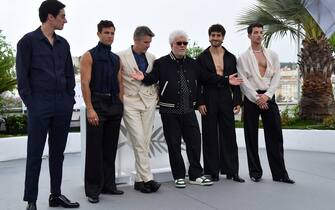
(0, 0), (297, 62)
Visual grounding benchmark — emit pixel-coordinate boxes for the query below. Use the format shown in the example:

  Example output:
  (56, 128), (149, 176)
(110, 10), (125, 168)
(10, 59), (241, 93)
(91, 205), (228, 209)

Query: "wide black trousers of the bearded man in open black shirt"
(202, 90), (239, 176)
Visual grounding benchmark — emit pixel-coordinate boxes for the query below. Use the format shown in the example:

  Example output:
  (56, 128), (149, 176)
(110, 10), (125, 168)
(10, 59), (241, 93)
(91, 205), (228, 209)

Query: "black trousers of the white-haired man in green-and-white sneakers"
(161, 111), (202, 180)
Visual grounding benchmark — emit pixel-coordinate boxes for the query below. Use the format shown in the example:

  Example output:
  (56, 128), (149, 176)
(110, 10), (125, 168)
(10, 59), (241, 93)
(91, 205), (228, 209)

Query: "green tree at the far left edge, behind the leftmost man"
(0, 30), (16, 94)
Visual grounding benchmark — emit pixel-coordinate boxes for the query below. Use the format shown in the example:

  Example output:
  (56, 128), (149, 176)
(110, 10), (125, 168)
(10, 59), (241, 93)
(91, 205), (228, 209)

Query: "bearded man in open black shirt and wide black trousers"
(197, 24), (244, 182)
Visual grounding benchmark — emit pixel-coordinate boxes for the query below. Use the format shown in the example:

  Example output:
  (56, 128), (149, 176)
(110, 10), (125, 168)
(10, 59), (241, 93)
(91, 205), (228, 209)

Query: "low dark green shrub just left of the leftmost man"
(6, 114), (27, 135)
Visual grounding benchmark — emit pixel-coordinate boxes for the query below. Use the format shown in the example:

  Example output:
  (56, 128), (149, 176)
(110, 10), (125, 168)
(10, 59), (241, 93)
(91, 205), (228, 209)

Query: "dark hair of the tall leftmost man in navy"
(38, 0), (65, 23)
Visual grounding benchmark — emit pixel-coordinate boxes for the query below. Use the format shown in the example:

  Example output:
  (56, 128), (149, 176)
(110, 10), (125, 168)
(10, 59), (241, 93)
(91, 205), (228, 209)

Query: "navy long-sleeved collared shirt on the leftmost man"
(16, 27), (75, 106)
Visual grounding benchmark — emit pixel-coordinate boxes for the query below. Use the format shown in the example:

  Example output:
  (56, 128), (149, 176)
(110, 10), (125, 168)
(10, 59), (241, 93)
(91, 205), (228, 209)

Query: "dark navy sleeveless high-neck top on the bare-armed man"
(89, 42), (120, 96)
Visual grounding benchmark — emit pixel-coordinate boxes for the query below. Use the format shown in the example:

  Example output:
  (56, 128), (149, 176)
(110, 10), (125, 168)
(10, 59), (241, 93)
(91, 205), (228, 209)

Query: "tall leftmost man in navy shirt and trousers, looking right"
(16, 0), (79, 210)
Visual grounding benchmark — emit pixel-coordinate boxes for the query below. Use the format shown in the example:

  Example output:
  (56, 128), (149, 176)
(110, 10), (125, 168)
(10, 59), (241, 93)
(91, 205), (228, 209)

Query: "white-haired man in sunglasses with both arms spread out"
(132, 31), (241, 188)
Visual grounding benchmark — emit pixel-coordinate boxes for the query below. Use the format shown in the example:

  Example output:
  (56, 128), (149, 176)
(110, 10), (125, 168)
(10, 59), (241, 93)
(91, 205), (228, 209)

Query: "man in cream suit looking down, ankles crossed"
(118, 26), (160, 193)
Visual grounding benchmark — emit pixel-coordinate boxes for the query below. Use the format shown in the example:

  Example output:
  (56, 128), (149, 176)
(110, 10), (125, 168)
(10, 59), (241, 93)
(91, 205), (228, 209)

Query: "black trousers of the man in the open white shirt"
(244, 97), (288, 179)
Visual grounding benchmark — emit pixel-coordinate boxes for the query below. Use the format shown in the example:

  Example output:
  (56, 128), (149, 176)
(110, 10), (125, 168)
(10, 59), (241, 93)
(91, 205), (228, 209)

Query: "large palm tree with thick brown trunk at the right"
(237, 0), (335, 120)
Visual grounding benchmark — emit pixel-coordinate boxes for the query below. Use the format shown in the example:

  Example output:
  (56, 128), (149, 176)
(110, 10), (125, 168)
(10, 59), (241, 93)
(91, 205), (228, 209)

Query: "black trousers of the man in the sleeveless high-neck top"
(85, 94), (123, 197)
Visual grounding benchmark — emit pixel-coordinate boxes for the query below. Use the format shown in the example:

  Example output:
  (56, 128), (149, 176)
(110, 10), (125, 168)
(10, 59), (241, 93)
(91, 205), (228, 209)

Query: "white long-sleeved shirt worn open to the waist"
(236, 47), (280, 103)
